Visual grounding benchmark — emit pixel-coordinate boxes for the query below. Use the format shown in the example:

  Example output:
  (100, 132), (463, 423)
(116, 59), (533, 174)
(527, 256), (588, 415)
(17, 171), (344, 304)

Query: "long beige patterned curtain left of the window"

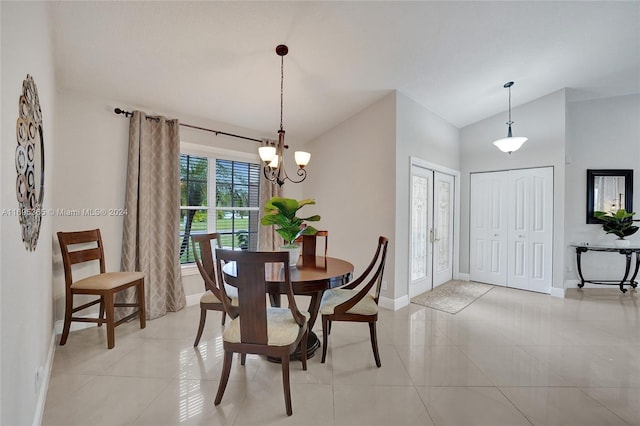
(121, 111), (186, 319)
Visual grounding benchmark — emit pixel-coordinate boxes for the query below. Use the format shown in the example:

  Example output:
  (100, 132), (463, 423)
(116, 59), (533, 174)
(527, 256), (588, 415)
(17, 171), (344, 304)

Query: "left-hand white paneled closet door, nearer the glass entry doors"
(469, 172), (508, 286)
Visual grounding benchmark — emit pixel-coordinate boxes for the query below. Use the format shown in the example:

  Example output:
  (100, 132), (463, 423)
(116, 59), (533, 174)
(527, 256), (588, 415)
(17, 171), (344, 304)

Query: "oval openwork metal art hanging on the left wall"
(16, 74), (44, 251)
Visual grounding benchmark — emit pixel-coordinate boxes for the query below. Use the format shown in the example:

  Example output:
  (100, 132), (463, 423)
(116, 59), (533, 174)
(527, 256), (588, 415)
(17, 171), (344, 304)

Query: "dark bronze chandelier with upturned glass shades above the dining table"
(258, 44), (311, 186)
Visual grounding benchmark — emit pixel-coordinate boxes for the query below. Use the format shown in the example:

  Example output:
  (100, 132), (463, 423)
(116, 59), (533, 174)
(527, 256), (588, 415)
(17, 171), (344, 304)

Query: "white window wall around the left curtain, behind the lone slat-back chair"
(53, 91), (268, 320)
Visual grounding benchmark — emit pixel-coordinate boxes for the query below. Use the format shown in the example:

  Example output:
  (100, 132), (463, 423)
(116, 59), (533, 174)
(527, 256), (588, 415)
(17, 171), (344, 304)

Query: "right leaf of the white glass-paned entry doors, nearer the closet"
(433, 172), (455, 288)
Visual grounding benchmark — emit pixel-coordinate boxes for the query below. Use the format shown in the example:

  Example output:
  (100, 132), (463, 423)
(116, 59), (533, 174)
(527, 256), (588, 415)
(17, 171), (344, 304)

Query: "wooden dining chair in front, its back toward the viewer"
(214, 249), (309, 416)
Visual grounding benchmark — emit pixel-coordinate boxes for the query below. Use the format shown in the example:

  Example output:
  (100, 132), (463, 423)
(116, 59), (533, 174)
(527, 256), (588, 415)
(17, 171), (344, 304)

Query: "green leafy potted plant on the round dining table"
(260, 197), (320, 266)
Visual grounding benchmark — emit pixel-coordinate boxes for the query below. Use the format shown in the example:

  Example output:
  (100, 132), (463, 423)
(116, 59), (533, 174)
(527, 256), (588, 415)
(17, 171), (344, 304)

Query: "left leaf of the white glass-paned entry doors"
(409, 166), (433, 297)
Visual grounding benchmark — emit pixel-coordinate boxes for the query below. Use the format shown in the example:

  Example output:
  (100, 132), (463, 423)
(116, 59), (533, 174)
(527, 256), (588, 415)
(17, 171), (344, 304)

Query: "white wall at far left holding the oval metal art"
(0, 2), (57, 425)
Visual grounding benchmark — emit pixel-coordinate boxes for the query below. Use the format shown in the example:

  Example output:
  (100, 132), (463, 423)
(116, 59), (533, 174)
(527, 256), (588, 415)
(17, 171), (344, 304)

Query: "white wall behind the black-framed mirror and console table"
(565, 95), (640, 287)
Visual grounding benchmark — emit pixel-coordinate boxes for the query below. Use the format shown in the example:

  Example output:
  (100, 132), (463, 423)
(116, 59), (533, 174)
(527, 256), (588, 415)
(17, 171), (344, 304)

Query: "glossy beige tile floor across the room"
(43, 287), (640, 426)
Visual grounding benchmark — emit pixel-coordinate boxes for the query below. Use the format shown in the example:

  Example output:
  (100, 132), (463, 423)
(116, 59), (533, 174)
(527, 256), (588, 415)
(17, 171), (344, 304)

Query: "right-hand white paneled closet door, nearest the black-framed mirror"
(507, 167), (553, 293)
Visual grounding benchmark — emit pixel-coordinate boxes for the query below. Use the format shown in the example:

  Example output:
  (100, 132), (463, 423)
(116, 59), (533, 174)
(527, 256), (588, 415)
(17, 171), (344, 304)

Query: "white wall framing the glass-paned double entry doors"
(394, 93), (460, 299)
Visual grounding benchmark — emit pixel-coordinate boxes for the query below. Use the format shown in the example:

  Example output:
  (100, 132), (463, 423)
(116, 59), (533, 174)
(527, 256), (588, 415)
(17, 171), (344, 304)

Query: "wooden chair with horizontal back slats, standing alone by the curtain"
(58, 229), (146, 349)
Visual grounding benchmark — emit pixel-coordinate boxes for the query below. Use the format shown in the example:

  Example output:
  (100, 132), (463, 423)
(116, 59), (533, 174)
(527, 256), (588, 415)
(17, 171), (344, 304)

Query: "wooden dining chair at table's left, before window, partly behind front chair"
(191, 232), (238, 347)
